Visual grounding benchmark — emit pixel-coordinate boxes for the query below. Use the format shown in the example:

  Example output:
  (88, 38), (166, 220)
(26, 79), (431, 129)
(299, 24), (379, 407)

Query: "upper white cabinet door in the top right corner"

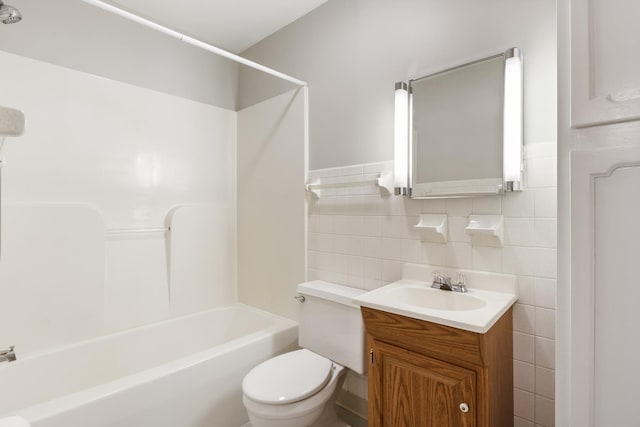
(571, 0), (640, 127)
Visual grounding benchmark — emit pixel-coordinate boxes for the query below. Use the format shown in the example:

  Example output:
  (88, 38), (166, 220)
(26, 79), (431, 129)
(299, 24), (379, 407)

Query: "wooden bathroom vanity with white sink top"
(354, 268), (517, 427)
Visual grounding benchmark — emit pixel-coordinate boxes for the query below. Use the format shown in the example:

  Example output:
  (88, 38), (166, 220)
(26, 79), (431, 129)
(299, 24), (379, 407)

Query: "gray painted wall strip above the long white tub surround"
(0, 0), (238, 110)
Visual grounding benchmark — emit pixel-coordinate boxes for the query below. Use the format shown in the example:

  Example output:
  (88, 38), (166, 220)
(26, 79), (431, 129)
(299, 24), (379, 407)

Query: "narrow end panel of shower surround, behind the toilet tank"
(237, 89), (306, 320)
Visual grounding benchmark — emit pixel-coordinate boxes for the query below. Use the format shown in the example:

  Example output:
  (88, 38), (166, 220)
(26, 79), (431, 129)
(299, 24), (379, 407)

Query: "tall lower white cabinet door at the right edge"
(570, 145), (640, 427)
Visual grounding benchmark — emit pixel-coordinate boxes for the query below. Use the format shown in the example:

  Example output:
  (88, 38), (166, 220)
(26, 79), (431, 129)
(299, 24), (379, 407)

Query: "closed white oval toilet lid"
(242, 349), (333, 405)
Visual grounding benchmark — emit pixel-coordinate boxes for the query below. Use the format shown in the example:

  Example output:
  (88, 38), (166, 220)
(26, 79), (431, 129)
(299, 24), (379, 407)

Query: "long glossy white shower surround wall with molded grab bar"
(0, 48), (236, 360)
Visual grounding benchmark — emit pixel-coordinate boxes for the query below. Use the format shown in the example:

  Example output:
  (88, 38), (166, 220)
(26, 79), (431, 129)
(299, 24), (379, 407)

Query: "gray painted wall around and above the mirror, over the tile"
(239, 0), (556, 169)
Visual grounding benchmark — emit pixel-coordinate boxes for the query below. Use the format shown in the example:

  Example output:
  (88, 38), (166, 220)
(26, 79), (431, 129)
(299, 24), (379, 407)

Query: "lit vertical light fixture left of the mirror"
(393, 82), (409, 196)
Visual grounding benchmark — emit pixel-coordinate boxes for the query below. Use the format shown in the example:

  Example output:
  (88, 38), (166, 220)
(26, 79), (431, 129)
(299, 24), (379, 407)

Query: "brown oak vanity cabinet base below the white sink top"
(361, 307), (513, 427)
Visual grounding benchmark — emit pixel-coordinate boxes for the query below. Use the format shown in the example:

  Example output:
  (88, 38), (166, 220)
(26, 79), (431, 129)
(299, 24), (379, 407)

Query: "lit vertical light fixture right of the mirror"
(503, 47), (523, 191)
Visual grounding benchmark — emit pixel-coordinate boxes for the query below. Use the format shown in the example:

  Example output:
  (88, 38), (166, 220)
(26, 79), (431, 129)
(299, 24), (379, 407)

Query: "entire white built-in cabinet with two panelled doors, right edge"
(556, 0), (640, 427)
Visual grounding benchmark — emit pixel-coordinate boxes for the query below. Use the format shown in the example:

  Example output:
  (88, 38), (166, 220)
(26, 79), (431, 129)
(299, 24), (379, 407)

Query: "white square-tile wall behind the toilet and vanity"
(308, 143), (557, 426)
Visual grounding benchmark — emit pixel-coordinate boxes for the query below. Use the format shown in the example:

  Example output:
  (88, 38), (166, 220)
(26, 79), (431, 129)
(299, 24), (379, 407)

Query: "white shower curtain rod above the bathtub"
(82, 0), (307, 86)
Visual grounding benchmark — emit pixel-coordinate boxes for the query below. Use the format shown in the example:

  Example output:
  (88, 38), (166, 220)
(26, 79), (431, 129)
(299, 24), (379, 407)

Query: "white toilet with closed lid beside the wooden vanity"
(242, 280), (367, 427)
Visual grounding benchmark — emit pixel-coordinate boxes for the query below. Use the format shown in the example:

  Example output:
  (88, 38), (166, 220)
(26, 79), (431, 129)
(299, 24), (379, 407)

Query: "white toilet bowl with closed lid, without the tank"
(242, 349), (346, 427)
